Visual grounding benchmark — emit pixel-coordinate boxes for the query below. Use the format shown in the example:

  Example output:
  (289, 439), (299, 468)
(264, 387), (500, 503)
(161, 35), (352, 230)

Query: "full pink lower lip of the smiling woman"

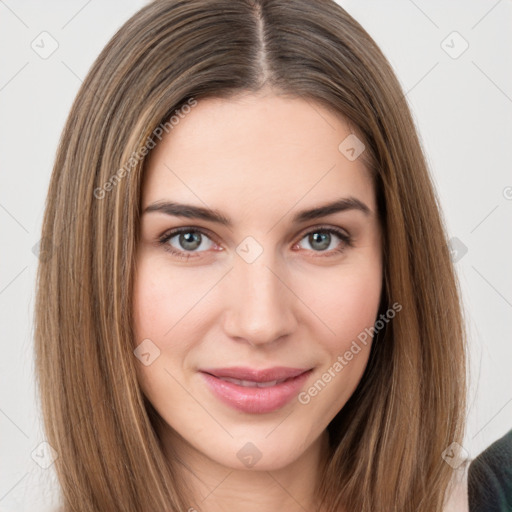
(200, 370), (311, 414)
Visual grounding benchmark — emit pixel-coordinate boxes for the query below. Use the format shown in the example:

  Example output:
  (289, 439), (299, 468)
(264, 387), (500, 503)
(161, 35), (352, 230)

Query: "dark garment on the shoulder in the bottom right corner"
(468, 430), (512, 512)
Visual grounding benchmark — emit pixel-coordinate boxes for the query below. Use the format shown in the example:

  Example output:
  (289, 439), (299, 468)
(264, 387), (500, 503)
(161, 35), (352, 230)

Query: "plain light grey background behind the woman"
(0, 0), (512, 512)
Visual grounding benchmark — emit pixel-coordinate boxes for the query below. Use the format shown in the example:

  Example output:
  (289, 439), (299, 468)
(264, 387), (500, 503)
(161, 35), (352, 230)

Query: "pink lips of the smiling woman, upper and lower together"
(199, 366), (312, 414)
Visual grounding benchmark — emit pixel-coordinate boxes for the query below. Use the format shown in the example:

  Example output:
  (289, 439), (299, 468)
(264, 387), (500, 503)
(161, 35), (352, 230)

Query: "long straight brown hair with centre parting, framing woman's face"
(35, 0), (466, 512)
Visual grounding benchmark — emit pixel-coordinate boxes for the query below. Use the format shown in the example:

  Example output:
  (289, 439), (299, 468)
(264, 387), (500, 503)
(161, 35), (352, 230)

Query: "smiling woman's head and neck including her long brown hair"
(36, 0), (466, 512)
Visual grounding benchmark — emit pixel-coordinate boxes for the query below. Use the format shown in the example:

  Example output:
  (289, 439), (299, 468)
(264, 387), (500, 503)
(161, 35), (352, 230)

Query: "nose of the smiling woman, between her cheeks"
(224, 253), (297, 346)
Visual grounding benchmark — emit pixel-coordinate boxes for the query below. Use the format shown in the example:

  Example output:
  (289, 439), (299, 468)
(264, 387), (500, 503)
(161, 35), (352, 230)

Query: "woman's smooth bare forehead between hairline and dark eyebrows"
(143, 94), (375, 216)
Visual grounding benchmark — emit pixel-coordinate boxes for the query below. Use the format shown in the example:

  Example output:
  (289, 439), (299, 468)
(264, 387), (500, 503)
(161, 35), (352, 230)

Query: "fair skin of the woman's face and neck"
(134, 91), (382, 512)
